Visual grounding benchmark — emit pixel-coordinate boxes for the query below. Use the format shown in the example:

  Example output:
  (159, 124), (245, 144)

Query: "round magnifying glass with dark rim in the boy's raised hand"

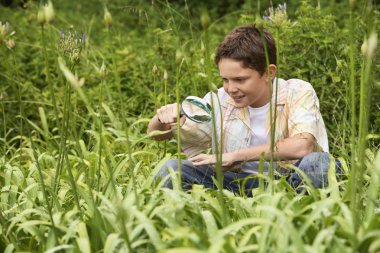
(180, 96), (212, 123)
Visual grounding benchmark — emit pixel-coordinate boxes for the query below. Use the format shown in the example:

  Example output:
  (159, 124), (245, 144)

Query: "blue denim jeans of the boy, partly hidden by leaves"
(155, 152), (340, 196)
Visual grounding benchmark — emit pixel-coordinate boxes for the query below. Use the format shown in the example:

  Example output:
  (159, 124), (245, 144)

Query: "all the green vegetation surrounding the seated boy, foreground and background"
(0, 0), (380, 253)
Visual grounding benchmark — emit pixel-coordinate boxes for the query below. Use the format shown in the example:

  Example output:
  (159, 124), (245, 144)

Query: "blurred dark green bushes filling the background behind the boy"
(1, 1), (380, 155)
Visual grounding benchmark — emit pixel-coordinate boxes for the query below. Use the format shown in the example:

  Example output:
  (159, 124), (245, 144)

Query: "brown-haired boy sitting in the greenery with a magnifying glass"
(148, 25), (329, 195)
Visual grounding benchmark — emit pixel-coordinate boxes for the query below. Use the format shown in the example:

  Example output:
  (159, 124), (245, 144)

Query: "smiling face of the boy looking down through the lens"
(218, 58), (271, 108)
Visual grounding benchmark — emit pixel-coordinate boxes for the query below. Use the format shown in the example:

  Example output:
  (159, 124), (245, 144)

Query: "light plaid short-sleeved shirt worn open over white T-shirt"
(172, 79), (329, 166)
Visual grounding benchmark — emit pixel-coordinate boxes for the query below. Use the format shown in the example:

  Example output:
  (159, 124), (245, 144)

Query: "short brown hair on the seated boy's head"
(215, 25), (277, 75)
